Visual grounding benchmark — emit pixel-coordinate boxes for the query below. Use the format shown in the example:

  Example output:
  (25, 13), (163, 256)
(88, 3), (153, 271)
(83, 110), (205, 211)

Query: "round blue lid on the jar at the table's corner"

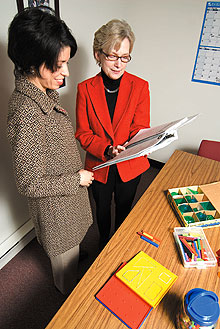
(184, 288), (220, 326)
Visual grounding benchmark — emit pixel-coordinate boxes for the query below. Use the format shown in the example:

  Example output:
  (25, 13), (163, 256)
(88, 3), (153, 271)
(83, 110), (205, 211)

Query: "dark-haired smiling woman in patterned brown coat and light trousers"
(8, 8), (93, 294)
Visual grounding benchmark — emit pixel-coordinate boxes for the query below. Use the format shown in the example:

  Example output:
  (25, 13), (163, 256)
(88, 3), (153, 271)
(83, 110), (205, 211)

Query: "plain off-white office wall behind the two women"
(0, 0), (220, 266)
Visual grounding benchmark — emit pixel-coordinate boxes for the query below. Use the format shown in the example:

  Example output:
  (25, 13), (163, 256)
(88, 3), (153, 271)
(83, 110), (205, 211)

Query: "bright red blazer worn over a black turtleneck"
(75, 72), (150, 183)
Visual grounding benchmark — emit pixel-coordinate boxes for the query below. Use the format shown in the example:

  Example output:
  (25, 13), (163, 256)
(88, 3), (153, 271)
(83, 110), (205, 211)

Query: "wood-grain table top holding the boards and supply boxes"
(47, 151), (220, 329)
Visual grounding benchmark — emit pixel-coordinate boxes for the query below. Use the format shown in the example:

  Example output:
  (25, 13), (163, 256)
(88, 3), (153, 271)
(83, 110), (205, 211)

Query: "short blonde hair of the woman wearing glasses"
(93, 19), (135, 61)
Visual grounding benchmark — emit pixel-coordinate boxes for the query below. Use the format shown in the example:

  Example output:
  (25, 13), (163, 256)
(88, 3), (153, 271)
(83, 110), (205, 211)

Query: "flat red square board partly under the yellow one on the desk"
(95, 264), (152, 329)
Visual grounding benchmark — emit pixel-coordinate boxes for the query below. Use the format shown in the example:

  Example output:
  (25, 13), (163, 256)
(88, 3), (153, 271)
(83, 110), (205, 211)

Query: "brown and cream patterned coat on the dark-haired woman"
(8, 75), (92, 257)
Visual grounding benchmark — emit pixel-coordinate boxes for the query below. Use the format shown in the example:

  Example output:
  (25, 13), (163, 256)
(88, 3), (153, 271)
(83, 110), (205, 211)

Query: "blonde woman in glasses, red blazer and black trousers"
(76, 19), (150, 247)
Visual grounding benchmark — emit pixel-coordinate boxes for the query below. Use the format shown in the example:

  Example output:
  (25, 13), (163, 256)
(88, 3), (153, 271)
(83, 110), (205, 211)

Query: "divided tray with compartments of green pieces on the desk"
(167, 182), (220, 228)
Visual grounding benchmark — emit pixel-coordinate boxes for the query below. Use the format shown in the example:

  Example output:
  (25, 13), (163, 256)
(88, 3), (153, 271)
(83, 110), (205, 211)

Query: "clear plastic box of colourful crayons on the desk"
(173, 227), (217, 269)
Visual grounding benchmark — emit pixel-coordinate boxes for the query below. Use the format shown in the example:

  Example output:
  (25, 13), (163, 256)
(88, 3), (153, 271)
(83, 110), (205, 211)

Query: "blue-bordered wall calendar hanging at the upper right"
(192, 1), (220, 86)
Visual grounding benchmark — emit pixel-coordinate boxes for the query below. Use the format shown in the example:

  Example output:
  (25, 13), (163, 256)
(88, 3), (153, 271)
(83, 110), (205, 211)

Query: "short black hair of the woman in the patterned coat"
(8, 8), (77, 75)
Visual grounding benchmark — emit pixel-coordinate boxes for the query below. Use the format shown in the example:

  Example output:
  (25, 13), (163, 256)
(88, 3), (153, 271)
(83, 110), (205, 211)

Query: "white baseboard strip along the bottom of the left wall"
(0, 220), (36, 269)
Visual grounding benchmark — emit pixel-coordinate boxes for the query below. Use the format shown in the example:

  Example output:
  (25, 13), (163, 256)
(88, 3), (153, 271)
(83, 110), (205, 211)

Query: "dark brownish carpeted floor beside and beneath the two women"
(0, 167), (160, 329)
